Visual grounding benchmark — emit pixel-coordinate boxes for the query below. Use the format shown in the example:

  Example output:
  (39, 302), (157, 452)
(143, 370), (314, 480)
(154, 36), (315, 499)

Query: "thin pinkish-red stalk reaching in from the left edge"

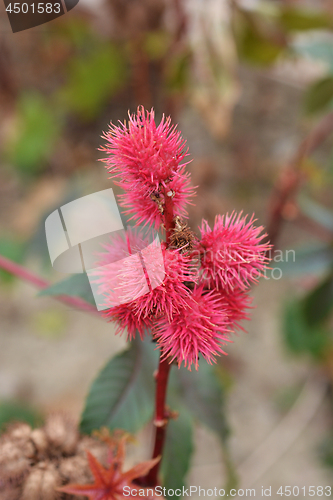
(0, 255), (98, 314)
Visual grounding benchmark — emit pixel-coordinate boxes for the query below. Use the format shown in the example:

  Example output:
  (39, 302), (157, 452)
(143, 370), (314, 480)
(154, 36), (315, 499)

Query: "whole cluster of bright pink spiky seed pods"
(96, 107), (270, 369)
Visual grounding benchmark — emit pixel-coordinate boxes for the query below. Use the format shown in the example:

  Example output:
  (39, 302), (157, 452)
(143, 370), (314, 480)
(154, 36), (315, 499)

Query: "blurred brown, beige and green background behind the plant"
(0, 0), (333, 496)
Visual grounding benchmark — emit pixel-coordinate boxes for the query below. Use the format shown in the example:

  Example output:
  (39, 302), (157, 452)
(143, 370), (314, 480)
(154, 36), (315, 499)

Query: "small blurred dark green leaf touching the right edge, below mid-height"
(302, 273), (333, 326)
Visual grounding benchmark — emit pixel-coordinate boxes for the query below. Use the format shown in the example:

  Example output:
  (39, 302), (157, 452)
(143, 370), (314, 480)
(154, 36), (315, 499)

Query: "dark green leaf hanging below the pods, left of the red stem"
(80, 339), (158, 433)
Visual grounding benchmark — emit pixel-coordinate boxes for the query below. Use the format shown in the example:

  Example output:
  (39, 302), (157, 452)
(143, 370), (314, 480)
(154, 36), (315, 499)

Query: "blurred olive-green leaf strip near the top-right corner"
(280, 7), (332, 31)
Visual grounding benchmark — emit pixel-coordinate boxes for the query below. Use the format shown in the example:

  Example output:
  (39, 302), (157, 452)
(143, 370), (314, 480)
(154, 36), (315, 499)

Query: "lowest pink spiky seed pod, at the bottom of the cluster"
(153, 285), (231, 370)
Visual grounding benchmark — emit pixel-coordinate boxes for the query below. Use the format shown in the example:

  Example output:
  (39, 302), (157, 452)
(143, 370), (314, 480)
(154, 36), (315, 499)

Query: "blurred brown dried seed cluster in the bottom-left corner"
(0, 414), (107, 500)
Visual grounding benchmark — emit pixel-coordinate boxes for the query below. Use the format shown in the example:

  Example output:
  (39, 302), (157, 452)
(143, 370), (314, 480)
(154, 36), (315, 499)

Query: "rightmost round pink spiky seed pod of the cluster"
(196, 212), (271, 292)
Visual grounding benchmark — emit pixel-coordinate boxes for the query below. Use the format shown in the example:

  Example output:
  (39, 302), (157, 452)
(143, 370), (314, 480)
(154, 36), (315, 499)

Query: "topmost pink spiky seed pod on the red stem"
(101, 106), (195, 227)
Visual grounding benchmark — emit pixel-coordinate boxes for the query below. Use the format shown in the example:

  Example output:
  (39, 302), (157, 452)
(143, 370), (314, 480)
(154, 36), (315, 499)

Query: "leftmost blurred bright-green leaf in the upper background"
(7, 92), (60, 174)
